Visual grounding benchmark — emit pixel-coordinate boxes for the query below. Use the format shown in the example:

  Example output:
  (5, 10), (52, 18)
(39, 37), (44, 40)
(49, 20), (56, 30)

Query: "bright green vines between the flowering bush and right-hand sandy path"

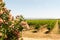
(27, 19), (56, 30)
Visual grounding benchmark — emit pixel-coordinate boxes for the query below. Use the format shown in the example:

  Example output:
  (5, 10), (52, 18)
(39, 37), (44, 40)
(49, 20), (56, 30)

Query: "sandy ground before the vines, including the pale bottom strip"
(22, 21), (60, 40)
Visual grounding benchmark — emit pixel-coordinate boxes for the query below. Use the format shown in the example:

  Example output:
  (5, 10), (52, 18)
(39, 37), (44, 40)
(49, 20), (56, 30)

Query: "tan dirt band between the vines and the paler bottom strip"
(22, 31), (60, 38)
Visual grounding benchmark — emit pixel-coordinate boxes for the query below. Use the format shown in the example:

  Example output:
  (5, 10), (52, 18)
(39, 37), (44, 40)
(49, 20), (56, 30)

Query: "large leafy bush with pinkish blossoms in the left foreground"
(0, 3), (24, 40)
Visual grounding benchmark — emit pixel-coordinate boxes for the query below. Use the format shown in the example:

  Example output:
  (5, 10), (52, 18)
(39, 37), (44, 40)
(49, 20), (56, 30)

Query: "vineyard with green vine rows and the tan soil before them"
(23, 19), (60, 40)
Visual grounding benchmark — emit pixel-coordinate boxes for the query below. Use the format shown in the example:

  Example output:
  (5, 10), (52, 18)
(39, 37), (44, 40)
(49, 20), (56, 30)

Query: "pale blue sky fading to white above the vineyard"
(4, 0), (60, 18)
